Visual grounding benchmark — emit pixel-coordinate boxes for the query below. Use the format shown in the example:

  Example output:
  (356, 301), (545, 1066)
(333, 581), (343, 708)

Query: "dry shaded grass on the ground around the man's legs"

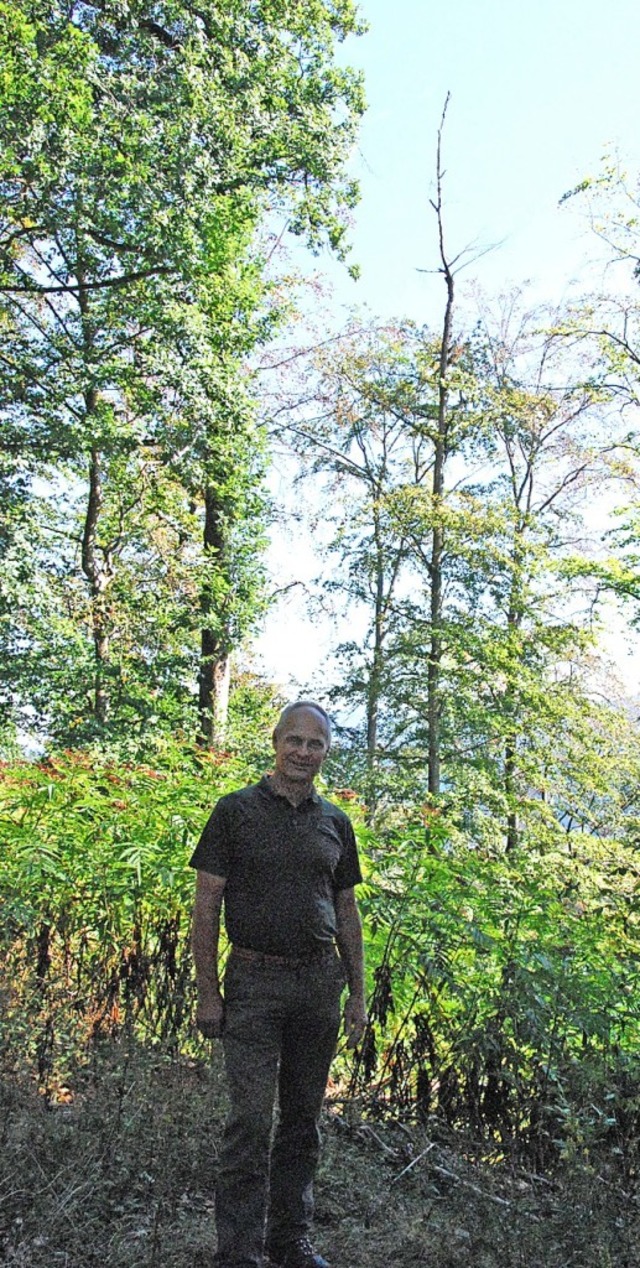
(0, 1040), (640, 1268)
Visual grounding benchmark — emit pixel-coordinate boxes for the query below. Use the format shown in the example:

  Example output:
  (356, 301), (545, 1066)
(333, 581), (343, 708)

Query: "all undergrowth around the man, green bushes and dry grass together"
(0, 753), (640, 1268)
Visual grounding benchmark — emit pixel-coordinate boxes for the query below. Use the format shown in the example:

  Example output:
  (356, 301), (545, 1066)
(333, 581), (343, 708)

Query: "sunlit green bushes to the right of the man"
(351, 813), (640, 1165)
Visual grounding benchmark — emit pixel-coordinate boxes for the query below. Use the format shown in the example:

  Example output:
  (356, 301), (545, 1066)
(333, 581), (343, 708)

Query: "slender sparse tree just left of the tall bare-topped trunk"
(289, 317), (437, 801)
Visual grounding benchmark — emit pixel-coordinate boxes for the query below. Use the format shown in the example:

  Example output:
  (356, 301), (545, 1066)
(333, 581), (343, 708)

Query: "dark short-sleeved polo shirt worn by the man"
(190, 776), (362, 956)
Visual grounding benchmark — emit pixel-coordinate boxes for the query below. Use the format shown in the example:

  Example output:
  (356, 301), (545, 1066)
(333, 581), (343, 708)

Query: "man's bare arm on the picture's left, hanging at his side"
(191, 871), (227, 1038)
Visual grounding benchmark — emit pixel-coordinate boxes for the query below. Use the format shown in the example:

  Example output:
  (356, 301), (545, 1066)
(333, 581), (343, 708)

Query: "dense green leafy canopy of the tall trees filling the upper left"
(0, 3), (362, 738)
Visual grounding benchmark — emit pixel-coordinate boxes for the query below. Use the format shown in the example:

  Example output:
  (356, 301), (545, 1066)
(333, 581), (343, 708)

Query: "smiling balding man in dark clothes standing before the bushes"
(191, 700), (366, 1268)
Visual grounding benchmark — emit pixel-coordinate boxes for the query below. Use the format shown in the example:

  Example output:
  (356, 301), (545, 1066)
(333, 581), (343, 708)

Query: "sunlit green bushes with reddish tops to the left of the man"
(0, 751), (243, 1087)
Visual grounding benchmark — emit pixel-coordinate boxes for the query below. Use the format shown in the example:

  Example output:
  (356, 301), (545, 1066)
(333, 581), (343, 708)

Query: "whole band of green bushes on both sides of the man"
(0, 748), (640, 1172)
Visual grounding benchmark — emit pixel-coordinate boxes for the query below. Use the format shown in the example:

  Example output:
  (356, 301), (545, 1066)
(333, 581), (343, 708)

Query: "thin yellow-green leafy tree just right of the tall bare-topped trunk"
(395, 290), (638, 850)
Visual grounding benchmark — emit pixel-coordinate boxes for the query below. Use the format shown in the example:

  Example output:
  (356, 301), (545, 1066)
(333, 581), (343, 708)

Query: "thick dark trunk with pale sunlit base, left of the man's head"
(198, 486), (231, 748)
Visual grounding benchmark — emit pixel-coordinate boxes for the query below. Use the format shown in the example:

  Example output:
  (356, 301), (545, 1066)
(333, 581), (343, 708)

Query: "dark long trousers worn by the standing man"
(214, 951), (345, 1268)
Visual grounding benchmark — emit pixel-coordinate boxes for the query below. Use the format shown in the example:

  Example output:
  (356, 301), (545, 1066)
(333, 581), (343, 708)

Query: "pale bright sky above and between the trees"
(252, 0), (640, 692)
